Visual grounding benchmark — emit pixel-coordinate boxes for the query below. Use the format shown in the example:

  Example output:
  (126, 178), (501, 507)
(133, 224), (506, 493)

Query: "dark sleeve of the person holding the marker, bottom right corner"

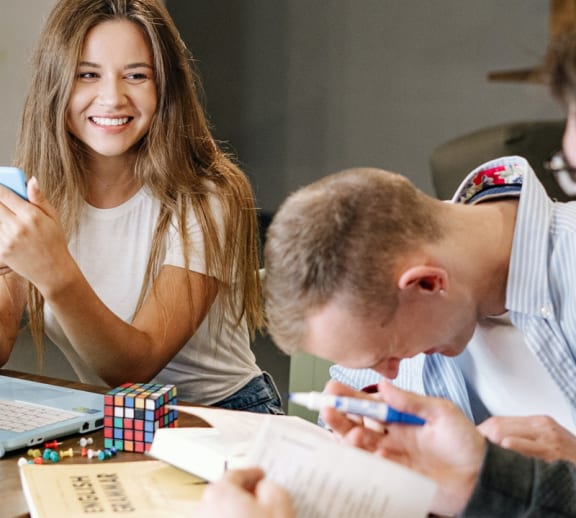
(461, 442), (576, 518)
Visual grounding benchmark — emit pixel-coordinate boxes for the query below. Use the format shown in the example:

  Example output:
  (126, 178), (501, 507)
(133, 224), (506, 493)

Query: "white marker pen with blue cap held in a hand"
(288, 392), (426, 425)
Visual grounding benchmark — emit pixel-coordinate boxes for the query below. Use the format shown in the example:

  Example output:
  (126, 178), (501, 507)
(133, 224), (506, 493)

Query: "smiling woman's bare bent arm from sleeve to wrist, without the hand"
(44, 266), (217, 386)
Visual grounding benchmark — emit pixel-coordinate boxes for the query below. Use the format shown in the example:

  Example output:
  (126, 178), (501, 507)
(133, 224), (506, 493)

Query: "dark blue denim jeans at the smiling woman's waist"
(212, 372), (284, 414)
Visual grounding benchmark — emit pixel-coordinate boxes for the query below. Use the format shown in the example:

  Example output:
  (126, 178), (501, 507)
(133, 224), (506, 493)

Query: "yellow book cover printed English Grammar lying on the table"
(20, 460), (206, 518)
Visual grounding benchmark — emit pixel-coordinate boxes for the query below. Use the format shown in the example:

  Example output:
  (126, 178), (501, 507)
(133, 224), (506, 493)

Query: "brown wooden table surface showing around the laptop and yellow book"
(0, 369), (209, 518)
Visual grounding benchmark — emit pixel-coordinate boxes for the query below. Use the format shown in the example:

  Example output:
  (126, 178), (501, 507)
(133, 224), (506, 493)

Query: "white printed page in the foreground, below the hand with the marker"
(248, 420), (436, 518)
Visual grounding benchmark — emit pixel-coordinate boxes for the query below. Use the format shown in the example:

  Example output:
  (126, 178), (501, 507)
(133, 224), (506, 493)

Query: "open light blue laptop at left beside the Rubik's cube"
(0, 375), (104, 457)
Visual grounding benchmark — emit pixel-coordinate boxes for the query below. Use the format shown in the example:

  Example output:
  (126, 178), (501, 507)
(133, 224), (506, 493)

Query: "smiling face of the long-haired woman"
(67, 20), (158, 158)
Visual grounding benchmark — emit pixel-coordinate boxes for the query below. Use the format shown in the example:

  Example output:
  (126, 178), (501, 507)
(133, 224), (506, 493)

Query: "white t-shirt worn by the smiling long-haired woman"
(45, 189), (261, 405)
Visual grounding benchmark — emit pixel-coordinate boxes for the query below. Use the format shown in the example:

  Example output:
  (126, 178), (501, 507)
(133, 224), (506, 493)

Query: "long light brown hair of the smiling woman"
(16, 0), (262, 354)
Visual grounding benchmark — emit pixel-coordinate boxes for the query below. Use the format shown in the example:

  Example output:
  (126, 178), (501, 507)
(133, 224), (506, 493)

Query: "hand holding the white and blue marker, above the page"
(322, 381), (486, 515)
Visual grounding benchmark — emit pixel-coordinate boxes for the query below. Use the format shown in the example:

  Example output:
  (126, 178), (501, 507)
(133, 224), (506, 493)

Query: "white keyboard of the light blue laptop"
(0, 399), (78, 432)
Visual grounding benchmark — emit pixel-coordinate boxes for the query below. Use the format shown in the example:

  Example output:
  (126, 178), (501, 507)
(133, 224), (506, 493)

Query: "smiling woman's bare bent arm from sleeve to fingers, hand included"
(0, 179), (218, 385)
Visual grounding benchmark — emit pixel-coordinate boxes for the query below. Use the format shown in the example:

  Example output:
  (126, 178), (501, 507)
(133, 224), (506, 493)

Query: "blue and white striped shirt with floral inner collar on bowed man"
(330, 157), (576, 422)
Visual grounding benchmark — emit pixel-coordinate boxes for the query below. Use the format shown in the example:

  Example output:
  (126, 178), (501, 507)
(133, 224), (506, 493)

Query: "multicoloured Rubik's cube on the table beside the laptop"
(104, 383), (178, 453)
